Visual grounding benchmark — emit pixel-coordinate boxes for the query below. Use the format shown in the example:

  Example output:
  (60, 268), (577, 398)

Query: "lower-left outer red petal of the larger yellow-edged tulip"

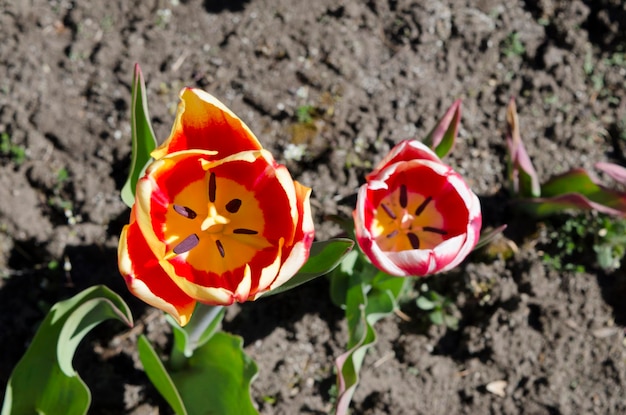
(118, 210), (196, 326)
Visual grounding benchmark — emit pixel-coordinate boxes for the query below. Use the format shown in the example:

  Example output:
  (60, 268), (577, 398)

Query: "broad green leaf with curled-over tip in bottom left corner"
(1, 286), (133, 415)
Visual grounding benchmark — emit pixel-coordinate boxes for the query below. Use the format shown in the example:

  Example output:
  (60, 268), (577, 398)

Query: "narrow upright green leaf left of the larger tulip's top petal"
(122, 65), (156, 207)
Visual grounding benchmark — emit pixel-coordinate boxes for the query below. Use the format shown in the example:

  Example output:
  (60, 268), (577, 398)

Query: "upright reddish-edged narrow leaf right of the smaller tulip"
(506, 97), (541, 197)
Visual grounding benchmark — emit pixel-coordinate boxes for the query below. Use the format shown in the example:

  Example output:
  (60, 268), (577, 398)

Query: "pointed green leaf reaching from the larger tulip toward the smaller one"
(262, 238), (354, 297)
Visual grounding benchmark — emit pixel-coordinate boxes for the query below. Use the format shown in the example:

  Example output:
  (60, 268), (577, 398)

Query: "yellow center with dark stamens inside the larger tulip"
(164, 171), (270, 271)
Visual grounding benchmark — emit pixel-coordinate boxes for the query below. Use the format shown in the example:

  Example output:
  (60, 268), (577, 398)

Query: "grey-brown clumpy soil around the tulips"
(0, 0), (626, 415)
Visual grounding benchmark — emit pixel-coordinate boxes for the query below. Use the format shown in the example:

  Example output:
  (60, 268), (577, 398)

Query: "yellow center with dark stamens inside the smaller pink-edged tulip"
(372, 184), (448, 251)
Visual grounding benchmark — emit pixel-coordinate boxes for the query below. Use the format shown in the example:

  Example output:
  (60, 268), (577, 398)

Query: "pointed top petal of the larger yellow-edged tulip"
(152, 88), (261, 160)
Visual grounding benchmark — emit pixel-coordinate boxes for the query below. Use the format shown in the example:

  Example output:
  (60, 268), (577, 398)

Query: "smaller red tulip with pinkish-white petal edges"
(353, 140), (482, 276)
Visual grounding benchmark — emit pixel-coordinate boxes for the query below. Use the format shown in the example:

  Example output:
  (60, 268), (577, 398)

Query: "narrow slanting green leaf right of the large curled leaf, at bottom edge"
(137, 334), (187, 415)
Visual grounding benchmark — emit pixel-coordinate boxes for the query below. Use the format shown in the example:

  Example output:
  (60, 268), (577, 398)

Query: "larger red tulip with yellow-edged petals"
(118, 88), (314, 325)
